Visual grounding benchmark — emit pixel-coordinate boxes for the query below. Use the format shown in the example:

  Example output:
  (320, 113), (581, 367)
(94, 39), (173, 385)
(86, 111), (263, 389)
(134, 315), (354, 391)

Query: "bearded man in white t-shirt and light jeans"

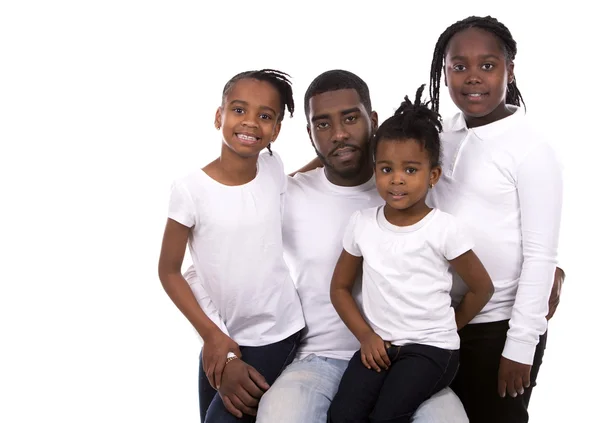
(187, 70), (468, 423)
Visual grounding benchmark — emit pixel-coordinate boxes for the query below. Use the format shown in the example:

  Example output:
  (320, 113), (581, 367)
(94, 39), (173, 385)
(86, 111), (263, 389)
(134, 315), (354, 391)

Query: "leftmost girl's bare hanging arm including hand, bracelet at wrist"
(158, 219), (241, 389)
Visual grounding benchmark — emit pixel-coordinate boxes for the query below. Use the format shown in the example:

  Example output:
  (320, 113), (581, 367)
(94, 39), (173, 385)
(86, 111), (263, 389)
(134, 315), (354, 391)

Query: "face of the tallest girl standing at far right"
(444, 28), (514, 127)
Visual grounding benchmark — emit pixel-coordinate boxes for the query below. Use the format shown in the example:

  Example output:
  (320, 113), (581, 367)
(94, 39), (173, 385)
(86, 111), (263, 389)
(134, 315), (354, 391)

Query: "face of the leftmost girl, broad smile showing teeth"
(215, 79), (281, 157)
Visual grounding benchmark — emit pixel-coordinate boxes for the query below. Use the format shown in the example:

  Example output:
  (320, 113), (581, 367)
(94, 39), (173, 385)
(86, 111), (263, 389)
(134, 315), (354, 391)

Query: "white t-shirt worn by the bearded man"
(283, 168), (383, 360)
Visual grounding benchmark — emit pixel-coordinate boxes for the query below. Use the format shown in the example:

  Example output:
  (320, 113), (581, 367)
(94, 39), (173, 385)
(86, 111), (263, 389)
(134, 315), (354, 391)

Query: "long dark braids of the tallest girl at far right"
(429, 16), (525, 112)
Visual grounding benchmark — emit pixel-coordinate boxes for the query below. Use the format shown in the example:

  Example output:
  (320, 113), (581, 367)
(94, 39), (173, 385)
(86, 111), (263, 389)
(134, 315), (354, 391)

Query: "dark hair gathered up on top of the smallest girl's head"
(371, 84), (442, 168)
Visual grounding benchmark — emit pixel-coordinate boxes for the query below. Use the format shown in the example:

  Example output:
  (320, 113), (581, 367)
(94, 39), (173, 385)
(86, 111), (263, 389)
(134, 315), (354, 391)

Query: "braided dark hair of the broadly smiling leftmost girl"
(221, 69), (294, 155)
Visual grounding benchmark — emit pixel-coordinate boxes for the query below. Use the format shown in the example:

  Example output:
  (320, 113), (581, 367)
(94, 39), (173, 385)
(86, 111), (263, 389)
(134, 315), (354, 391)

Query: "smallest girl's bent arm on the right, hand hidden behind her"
(449, 250), (494, 330)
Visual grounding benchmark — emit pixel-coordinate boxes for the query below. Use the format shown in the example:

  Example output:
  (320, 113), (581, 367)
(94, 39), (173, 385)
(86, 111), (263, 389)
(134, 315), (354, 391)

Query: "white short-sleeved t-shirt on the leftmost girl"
(168, 153), (304, 346)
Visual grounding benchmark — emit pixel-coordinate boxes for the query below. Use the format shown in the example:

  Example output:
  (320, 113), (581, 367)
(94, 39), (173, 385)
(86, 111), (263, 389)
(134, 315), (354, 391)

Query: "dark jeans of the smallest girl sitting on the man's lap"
(328, 344), (459, 423)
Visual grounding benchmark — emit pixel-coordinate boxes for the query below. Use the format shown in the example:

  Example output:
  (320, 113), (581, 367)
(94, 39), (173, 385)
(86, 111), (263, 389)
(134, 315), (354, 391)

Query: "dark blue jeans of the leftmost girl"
(198, 332), (300, 423)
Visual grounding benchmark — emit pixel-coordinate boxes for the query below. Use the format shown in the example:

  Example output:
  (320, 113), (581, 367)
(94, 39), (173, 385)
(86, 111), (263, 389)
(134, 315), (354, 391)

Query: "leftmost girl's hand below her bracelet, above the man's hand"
(202, 330), (242, 390)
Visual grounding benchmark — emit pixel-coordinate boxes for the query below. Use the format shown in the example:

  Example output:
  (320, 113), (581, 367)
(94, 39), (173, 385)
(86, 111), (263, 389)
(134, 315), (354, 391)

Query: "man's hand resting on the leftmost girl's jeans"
(219, 359), (269, 419)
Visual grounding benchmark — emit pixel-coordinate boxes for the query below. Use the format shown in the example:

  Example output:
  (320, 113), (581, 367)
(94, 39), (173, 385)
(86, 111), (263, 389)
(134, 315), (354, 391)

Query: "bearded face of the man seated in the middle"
(308, 89), (377, 185)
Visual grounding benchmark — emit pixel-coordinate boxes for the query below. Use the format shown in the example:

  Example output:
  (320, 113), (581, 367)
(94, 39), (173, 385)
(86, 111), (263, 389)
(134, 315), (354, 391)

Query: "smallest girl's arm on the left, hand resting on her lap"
(331, 250), (391, 372)
